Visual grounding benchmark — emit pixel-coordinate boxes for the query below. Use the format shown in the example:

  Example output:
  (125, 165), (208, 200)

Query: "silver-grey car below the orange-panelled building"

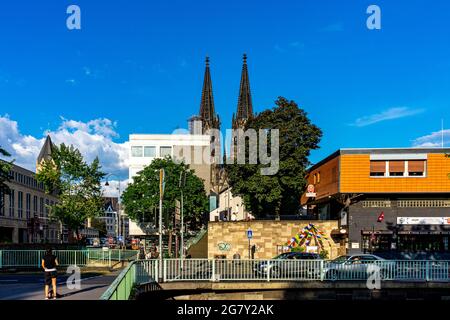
(323, 254), (396, 281)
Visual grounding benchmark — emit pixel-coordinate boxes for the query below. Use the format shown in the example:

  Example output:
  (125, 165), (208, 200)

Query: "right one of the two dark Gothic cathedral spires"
(233, 53), (253, 128)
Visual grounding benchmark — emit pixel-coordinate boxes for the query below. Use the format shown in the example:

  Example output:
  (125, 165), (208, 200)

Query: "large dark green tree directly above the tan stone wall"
(227, 97), (322, 217)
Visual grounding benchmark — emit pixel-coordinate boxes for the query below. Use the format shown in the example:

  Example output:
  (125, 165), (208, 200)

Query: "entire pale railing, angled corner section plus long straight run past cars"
(101, 259), (450, 300)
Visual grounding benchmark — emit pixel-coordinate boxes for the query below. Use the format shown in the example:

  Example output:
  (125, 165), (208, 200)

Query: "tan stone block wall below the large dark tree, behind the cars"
(208, 220), (340, 259)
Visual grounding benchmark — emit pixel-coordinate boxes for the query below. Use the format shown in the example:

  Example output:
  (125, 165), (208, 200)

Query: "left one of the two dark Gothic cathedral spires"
(199, 57), (219, 131)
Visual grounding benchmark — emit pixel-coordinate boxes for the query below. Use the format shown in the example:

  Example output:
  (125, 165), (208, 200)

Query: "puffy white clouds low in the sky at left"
(0, 115), (128, 177)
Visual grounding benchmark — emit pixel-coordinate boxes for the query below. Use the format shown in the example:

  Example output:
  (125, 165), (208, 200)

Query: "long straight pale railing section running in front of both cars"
(163, 259), (450, 282)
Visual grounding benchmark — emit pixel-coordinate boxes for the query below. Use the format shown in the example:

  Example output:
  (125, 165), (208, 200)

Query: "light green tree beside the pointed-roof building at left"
(36, 144), (105, 237)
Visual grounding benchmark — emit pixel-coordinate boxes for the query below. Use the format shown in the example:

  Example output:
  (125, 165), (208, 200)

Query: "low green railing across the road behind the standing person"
(0, 249), (138, 269)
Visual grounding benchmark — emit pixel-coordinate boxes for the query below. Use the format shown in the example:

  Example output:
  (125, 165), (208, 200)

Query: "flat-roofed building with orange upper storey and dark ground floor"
(301, 148), (450, 255)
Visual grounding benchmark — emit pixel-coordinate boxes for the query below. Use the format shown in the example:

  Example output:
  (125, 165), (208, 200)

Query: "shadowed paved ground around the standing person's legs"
(0, 271), (119, 300)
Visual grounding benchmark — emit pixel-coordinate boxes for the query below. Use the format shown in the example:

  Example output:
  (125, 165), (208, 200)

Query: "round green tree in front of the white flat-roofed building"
(122, 157), (208, 228)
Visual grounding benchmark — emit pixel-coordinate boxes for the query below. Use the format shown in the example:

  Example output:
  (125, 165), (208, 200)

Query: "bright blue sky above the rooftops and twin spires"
(0, 0), (450, 180)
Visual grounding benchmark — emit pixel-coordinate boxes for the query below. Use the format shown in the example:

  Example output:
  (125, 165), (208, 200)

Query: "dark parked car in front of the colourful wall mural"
(254, 252), (321, 279)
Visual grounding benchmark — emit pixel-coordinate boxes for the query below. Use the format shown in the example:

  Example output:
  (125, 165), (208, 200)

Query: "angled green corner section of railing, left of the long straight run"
(100, 260), (158, 300)
